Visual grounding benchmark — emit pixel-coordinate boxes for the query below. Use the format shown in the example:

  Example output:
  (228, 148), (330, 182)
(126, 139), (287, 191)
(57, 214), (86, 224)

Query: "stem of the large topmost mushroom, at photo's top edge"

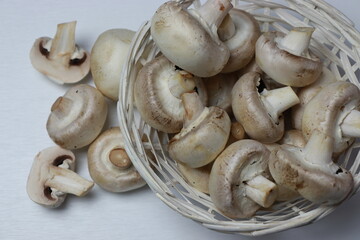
(198, 0), (233, 29)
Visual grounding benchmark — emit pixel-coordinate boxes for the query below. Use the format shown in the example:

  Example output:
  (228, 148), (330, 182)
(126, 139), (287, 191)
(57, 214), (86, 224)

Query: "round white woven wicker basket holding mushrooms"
(118, 0), (360, 235)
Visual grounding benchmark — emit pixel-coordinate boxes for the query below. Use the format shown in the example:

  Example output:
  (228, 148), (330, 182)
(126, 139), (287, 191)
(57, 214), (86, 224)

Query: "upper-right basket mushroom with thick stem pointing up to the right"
(255, 27), (322, 87)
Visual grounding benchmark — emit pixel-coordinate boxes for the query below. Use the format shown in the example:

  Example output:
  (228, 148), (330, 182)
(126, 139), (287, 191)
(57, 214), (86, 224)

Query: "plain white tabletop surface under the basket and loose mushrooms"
(0, 0), (360, 240)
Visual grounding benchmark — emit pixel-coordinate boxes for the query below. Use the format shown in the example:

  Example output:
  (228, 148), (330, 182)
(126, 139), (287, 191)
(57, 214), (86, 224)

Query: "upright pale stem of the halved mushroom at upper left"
(49, 21), (76, 65)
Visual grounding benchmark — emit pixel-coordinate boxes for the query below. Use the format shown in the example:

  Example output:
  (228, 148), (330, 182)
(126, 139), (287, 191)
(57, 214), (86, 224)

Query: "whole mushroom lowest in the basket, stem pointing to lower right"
(209, 139), (277, 218)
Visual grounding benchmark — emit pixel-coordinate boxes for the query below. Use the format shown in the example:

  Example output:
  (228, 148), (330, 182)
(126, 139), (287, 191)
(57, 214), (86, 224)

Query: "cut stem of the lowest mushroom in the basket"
(245, 175), (277, 208)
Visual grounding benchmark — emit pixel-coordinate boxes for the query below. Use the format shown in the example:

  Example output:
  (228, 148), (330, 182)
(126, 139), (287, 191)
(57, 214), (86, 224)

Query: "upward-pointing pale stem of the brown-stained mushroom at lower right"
(303, 130), (334, 166)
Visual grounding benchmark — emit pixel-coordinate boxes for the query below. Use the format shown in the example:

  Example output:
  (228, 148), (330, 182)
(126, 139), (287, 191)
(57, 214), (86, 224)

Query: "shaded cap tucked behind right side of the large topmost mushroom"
(221, 9), (261, 73)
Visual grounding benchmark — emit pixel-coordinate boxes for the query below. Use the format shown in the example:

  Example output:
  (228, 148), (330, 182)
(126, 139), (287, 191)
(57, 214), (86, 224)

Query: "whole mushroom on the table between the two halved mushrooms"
(46, 84), (107, 149)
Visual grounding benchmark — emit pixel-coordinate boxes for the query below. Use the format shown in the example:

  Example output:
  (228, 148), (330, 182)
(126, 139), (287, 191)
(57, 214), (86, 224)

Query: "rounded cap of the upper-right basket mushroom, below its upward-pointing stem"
(255, 32), (322, 87)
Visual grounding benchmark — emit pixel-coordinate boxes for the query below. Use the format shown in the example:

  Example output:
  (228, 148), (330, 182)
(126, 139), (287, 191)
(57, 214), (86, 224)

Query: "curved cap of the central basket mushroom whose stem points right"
(231, 72), (284, 143)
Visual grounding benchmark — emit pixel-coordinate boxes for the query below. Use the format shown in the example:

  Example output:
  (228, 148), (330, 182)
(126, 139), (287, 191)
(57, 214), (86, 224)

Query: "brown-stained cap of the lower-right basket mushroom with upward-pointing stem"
(269, 142), (354, 205)
